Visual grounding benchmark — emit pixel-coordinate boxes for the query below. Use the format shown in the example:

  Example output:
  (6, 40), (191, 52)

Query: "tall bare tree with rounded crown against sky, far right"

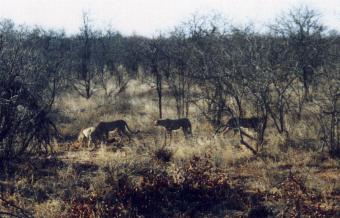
(272, 7), (325, 99)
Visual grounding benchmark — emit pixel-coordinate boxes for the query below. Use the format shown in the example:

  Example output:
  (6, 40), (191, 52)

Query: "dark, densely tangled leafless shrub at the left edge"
(0, 77), (55, 163)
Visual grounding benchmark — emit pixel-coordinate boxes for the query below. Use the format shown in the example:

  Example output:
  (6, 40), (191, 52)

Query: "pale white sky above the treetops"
(0, 0), (340, 36)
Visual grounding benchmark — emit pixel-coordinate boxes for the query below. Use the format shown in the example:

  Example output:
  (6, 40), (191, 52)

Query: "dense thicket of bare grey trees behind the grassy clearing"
(0, 8), (340, 156)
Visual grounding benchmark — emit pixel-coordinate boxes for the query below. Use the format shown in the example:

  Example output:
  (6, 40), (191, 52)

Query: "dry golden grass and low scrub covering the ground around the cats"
(0, 77), (340, 217)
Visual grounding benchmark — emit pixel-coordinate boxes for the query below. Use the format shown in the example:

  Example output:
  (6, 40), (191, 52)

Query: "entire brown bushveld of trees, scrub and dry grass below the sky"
(0, 5), (340, 217)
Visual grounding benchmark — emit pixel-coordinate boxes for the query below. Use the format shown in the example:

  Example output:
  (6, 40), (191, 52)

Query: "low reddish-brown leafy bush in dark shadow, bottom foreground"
(70, 157), (260, 217)
